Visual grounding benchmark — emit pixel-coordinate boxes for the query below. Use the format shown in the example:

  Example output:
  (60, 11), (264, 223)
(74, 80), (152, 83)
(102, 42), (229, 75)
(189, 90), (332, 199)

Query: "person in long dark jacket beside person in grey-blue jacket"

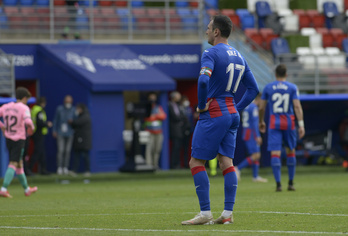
(70, 103), (92, 177)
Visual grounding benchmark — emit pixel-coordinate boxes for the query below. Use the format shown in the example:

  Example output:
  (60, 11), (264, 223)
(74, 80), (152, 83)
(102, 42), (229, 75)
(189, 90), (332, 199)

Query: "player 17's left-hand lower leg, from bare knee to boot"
(181, 157), (213, 225)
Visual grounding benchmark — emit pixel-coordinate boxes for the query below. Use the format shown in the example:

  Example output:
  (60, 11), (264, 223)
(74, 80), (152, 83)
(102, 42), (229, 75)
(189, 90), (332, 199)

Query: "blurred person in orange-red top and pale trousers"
(145, 92), (167, 169)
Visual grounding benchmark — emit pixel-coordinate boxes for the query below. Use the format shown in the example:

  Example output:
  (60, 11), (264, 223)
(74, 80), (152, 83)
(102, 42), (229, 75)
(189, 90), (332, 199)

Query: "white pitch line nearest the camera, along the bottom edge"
(0, 226), (348, 235)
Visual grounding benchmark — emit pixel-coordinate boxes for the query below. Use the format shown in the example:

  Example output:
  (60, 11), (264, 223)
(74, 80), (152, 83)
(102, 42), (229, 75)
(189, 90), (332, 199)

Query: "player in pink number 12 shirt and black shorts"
(0, 87), (37, 198)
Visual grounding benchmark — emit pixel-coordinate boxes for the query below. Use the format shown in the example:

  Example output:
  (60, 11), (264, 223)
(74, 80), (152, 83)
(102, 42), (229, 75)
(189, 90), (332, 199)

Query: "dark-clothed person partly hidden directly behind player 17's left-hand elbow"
(181, 96), (194, 168)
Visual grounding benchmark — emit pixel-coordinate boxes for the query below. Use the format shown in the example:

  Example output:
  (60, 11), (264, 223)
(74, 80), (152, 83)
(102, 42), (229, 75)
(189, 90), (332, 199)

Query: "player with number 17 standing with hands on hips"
(182, 15), (259, 225)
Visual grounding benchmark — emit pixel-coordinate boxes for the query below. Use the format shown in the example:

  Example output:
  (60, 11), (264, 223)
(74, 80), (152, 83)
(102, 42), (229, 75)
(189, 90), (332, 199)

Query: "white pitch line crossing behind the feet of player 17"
(0, 211), (348, 218)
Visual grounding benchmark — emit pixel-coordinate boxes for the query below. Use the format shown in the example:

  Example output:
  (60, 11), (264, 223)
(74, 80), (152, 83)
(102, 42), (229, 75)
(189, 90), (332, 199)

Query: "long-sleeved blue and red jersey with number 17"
(198, 43), (258, 119)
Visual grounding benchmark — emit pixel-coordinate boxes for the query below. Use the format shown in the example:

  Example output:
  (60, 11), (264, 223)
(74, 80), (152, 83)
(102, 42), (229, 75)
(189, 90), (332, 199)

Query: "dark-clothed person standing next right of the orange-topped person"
(169, 91), (186, 169)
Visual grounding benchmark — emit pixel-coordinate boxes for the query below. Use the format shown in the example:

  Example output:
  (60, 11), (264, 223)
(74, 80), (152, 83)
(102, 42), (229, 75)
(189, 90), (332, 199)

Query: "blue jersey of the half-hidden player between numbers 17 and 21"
(242, 102), (260, 141)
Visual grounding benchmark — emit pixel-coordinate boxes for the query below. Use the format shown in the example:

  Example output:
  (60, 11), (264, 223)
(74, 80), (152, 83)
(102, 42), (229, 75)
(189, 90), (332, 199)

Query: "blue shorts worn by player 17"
(191, 113), (240, 160)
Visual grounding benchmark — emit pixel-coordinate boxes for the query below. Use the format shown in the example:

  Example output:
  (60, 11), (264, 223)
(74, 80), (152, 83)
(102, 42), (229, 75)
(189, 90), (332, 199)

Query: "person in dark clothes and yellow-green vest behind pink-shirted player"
(28, 97), (52, 175)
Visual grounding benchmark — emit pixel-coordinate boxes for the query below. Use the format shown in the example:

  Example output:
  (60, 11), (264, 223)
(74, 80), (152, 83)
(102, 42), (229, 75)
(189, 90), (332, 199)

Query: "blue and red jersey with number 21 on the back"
(261, 81), (299, 130)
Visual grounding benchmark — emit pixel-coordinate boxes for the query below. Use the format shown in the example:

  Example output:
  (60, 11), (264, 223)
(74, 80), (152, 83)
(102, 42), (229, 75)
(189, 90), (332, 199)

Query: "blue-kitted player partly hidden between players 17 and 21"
(235, 94), (268, 183)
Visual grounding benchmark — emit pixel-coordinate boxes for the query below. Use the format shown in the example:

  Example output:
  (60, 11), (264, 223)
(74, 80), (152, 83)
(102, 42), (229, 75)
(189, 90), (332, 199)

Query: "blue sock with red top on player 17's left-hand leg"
(191, 166), (210, 211)
